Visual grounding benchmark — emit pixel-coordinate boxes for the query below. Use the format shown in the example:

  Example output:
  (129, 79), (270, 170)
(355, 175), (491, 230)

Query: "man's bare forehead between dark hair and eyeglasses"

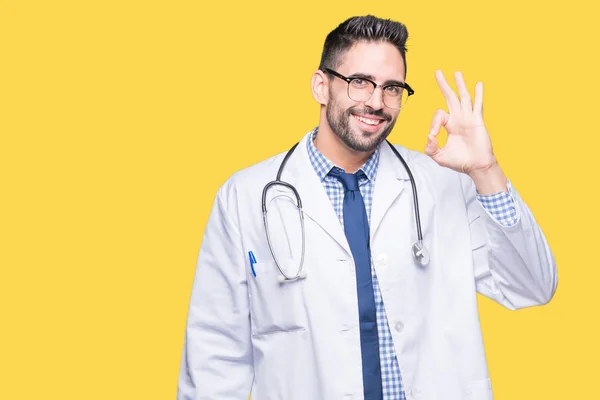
(337, 41), (405, 80)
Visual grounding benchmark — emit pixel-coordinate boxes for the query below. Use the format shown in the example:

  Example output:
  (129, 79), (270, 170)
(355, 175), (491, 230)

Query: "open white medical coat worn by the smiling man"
(177, 136), (557, 400)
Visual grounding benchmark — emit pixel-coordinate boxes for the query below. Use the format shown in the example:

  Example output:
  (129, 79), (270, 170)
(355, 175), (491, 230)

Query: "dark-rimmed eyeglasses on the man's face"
(323, 68), (415, 110)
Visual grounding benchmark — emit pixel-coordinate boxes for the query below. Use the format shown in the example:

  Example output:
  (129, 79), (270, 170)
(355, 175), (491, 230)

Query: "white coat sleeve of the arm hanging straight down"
(177, 180), (254, 400)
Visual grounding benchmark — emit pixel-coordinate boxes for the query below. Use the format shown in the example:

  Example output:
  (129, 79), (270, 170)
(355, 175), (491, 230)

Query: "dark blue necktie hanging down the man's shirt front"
(329, 168), (383, 400)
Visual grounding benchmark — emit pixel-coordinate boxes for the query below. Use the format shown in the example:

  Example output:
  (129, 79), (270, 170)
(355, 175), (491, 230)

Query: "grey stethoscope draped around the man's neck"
(262, 140), (429, 283)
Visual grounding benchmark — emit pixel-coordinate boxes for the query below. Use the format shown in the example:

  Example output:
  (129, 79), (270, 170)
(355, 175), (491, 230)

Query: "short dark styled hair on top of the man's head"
(319, 15), (408, 74)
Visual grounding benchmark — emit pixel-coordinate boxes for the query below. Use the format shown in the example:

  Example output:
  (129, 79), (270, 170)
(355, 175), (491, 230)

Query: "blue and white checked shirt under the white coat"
(306, 128), (518, 400)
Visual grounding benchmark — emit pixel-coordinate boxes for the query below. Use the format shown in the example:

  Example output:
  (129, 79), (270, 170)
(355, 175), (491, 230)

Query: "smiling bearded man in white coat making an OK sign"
(177, 16), (557, 400)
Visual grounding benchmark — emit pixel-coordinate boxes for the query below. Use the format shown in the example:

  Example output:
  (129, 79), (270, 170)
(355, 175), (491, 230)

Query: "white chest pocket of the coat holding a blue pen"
(248, 259), (307, 336)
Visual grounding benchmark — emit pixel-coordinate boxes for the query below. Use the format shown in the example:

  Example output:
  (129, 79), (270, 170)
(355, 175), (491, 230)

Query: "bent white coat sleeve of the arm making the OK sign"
(460, 174), (558, 310)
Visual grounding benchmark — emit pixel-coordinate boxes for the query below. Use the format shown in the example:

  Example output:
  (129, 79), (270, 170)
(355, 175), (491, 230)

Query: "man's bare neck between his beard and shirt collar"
(314, 120), (374, 174)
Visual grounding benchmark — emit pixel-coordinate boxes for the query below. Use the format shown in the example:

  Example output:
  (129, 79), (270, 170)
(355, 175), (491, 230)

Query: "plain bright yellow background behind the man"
(0, 0), (600, 400)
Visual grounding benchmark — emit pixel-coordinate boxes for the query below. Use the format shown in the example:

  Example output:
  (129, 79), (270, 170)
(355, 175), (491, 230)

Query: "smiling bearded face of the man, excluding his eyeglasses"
(326, 42), (405, 152)
